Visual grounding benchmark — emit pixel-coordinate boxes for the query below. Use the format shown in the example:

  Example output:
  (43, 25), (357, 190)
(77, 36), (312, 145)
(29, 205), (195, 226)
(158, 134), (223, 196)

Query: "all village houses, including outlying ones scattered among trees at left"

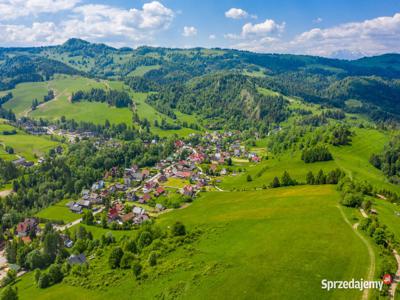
(0, 130), (261, 277)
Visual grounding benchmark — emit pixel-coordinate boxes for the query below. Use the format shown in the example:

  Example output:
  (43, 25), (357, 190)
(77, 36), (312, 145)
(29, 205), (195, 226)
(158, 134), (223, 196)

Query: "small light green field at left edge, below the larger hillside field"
(0, 122), (59, 161)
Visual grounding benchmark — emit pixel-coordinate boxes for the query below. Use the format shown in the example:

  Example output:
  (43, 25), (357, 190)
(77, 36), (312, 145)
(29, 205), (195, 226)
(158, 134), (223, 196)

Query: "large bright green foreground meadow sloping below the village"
(17, 186), (369, 300)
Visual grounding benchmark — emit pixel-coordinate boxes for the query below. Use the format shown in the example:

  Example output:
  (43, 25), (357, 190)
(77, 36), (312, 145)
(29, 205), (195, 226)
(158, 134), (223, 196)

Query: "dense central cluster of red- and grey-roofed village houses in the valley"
(62, 132), (261, 228)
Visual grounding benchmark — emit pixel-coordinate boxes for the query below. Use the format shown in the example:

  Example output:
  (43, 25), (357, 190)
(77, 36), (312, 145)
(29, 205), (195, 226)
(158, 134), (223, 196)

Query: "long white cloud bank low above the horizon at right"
(230, 13), (400, 58)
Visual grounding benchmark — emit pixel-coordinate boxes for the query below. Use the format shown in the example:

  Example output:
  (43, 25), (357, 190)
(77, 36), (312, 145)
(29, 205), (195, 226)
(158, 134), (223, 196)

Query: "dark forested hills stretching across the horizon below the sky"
(0, 39), (400, 121)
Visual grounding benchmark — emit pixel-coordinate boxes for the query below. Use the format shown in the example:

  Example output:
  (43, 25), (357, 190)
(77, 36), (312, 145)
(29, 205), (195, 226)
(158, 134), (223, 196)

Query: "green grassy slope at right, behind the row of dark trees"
(220, 129), (400, 192)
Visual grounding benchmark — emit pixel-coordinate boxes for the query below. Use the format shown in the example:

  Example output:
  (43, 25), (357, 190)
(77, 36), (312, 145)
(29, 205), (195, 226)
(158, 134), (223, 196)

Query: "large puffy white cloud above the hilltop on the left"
(0, 0), (175, 46)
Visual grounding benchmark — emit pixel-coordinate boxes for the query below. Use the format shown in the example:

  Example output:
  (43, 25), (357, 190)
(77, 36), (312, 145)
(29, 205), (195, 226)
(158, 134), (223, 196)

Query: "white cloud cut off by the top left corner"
(0, 0), (80, 20)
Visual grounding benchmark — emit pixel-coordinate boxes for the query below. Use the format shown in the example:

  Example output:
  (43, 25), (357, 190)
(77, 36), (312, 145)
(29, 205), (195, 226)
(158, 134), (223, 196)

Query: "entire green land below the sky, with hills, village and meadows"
(0, 35), (400, 300)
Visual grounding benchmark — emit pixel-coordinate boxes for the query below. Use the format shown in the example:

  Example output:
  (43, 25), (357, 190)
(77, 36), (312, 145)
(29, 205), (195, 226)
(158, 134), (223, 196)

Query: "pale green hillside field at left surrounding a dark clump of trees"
(4, 75), (202, 136)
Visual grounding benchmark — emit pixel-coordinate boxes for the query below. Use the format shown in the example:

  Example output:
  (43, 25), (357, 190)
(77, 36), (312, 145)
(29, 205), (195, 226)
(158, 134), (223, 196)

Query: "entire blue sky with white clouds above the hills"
(0, 0), (400, 58)
